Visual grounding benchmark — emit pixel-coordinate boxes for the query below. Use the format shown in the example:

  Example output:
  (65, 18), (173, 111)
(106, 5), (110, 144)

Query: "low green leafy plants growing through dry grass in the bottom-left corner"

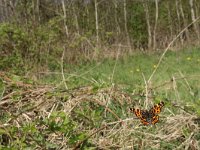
(0, 112), (86, 149)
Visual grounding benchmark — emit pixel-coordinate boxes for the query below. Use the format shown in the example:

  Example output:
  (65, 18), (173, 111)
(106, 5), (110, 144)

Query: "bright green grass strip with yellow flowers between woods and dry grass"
(37, 49), (200, 109)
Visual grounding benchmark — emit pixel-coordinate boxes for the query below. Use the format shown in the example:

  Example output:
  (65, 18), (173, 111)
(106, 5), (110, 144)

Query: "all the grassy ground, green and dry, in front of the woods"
(0, 49), (200, 149)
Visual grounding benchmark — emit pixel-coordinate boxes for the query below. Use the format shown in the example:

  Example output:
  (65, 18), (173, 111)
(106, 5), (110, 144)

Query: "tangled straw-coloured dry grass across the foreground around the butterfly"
(0, 73), (200, 150)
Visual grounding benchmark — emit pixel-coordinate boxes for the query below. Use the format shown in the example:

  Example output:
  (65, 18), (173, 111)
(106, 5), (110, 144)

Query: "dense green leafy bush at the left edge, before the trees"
(0, 18), (62, 74)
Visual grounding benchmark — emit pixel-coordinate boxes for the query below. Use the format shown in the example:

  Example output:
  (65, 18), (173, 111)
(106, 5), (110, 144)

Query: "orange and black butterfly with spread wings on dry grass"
(130, 102), (164, 125)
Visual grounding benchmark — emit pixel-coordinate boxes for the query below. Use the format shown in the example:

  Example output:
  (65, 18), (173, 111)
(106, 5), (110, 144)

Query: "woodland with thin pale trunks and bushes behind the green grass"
(0, 0), (200, 74)
